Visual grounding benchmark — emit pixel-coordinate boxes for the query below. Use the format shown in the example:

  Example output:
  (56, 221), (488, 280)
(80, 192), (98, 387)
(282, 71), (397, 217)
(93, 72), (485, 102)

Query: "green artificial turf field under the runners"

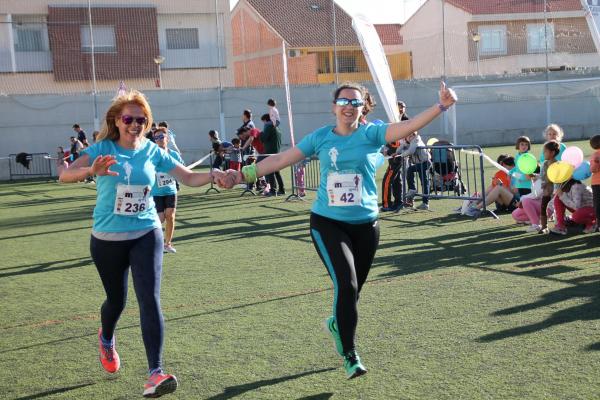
(0, 142), (600, 400)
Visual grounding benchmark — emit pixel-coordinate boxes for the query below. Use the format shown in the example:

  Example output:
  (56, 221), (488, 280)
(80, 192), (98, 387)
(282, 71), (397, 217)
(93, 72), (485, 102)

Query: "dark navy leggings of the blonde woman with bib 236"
(90, 229), (164, 370)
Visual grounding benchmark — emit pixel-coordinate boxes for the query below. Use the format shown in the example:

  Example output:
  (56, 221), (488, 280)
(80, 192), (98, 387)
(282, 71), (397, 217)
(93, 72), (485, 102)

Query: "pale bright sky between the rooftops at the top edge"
(230, 0), (424, 24)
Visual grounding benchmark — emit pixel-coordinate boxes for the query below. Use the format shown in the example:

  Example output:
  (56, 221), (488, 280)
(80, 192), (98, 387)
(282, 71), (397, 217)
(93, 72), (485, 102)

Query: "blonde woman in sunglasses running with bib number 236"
(60, 91), (223, 397)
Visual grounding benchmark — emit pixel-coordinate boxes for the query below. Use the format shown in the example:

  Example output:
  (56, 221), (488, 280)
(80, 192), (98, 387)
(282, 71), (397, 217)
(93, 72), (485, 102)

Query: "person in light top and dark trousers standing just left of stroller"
(400, 132), (431, 210)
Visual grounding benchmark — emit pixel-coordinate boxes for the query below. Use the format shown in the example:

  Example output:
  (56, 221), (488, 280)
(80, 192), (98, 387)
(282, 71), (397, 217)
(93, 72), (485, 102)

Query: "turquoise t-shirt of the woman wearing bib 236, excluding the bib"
(83, 139), (183, 232)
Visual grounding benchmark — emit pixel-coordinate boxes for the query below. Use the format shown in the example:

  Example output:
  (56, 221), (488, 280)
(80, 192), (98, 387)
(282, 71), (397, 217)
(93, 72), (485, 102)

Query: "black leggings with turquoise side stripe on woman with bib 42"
(310, 213), (379, 352)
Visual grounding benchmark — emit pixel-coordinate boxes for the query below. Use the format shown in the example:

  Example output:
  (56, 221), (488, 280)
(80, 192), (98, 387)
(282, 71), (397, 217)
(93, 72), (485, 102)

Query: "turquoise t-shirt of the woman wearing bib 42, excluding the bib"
(298, 123), (388, 224)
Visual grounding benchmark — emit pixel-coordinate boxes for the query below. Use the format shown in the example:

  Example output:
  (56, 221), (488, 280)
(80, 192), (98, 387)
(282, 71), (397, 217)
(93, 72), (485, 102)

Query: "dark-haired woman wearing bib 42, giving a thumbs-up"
(224, 83), (456, 378)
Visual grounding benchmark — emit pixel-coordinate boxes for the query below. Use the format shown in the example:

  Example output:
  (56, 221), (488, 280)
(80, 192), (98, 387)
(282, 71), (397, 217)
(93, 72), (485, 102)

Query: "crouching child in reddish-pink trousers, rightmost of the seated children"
(550, 179), (597, 235)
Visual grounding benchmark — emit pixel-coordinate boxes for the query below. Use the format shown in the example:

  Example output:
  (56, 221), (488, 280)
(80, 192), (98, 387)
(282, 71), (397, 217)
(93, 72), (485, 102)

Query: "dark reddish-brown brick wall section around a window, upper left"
(48, 6), (160, 81)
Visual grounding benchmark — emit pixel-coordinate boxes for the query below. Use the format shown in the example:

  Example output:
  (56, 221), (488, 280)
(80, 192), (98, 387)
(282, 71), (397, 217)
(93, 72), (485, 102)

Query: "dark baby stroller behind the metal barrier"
(431, 140), (467, 196)
